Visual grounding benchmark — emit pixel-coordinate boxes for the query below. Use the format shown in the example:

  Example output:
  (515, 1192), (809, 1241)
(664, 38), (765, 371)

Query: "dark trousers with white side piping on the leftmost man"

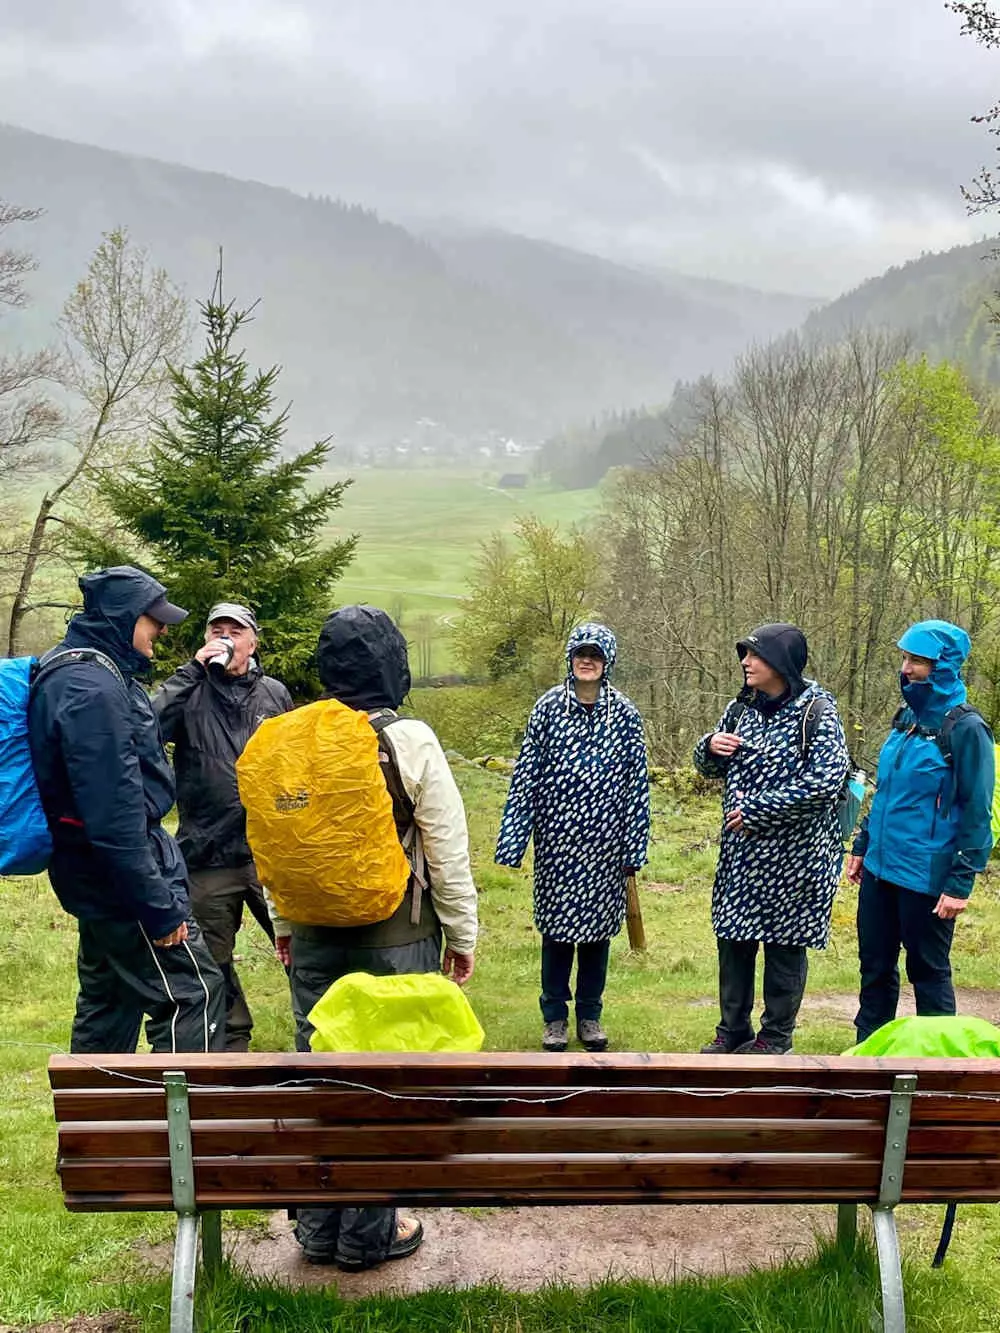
(69, 920), (225, 1054)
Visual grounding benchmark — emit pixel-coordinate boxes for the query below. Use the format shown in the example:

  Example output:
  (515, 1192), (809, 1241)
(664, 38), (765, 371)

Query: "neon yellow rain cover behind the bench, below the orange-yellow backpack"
(309, 972), (483, 1050)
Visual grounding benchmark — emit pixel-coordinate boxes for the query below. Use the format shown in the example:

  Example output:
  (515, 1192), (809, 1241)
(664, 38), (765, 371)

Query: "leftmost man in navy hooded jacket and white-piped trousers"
(28, 565), (225, 1053)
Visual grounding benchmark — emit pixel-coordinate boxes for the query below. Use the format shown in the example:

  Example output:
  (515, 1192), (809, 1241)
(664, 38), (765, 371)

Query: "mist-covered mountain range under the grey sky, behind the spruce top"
(0, 125), (812, 456)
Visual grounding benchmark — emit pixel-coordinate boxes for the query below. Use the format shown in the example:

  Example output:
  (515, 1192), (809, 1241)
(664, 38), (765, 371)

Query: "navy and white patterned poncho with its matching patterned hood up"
(496, 623), (649, 944)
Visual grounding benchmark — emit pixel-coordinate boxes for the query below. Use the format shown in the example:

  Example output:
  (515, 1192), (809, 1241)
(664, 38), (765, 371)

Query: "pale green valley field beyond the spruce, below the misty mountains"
(327, 468), (600, 677)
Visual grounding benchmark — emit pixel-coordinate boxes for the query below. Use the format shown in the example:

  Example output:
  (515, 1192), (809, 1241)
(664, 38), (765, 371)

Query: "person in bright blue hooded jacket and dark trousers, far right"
(847, 620), (993, 1041)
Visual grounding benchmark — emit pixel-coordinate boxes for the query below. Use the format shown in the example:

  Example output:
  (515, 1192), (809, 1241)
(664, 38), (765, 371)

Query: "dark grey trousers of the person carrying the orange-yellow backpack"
(289, 925), (441, 1268)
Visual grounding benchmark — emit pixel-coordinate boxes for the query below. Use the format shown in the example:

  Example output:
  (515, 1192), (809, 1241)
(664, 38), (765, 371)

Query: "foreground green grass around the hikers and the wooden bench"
(0, 764), (1000, 1333)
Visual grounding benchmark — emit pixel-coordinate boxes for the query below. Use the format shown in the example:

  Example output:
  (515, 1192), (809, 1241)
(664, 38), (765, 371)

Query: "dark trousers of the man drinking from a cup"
(188, 861), (275, 1050)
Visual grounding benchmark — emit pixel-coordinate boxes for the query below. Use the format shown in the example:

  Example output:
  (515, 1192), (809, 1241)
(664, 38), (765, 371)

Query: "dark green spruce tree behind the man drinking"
(80, 276), (356, 696)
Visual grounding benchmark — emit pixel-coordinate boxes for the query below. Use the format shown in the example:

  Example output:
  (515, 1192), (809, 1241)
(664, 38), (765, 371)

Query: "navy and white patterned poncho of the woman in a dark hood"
(695, 681), (848, 949)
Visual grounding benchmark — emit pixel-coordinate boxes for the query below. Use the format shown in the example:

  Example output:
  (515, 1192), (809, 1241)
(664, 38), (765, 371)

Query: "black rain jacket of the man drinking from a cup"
(153, 661), (292, 870)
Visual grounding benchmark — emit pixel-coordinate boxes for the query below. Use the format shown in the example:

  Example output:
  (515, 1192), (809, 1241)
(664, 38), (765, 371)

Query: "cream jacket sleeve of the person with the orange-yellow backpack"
(388, 717), (479, 953)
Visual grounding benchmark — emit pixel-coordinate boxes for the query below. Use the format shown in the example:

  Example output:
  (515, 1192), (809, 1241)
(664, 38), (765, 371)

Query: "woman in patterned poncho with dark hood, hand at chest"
(695, 624), (848, 1054)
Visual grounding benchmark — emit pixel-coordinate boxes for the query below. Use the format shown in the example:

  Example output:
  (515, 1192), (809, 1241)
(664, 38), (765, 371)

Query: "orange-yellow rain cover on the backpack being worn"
(236, 698), (409, 925)
